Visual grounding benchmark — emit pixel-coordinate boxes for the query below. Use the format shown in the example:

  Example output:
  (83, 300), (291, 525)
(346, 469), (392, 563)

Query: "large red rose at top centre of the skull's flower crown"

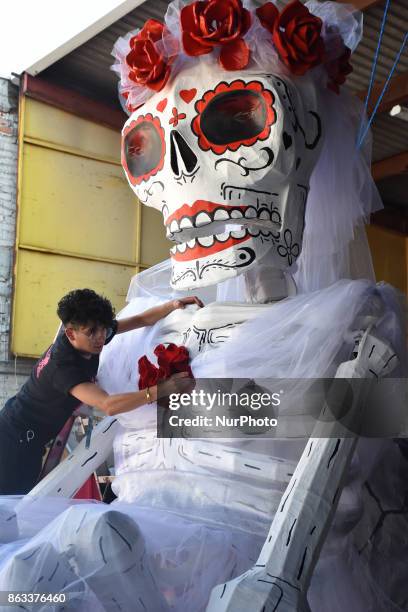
(180, 0), (251, 70)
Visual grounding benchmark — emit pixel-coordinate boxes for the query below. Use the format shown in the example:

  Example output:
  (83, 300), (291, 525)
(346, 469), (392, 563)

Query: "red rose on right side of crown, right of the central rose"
(256, 0), (324, 76)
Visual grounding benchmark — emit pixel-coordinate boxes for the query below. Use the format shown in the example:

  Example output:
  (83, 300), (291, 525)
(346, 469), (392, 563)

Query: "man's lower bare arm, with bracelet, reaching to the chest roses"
(70, 372), (193, 416)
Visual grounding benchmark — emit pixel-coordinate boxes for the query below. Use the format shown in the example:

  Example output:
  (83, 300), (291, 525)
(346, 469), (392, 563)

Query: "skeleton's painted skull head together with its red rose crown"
(115, 0), (356, 290)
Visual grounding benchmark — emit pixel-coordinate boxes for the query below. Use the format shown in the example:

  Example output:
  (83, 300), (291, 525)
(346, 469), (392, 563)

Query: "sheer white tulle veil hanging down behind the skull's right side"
(294, 86), (383, 292)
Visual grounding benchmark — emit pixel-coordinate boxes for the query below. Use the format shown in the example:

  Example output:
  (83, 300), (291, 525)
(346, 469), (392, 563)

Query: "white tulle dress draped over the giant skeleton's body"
(0, 264), (408, 612)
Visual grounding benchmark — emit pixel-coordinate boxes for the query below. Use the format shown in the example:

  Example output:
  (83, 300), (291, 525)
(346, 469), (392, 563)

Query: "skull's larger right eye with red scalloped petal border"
(191, 79), (276, 155)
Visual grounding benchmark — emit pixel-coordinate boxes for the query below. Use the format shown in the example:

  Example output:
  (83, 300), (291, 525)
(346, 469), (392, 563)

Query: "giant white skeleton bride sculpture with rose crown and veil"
(0, 0), (406, 612)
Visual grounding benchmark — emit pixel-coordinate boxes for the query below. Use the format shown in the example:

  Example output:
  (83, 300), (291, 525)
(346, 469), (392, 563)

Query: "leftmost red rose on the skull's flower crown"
(126, 19), (171, 91)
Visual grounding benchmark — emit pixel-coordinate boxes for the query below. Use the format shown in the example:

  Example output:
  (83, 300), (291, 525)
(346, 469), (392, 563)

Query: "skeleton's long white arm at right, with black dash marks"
(207, 328), (398, 612)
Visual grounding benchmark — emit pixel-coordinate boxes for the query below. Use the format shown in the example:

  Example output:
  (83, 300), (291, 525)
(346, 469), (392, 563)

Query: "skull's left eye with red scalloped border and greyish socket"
(122, 113), (166, 185)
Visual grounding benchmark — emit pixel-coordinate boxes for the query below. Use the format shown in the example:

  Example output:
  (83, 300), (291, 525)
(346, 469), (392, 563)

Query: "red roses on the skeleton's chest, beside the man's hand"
(138, 342), (193, 389)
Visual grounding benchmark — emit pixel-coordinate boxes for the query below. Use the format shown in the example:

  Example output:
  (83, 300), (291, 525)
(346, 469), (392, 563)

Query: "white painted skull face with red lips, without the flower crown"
(122, 62), (322, 290)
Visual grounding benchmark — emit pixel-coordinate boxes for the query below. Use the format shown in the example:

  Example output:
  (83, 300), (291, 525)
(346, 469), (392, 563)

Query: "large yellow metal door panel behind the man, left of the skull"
(11, 97), (168, 357)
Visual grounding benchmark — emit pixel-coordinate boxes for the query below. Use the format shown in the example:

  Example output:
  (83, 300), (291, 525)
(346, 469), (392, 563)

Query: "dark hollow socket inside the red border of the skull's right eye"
(200, 90), (267, 145)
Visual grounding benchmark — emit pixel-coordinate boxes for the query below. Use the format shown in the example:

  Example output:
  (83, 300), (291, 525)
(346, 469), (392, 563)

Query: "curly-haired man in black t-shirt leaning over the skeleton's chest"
(0, 289), (203, 495)
